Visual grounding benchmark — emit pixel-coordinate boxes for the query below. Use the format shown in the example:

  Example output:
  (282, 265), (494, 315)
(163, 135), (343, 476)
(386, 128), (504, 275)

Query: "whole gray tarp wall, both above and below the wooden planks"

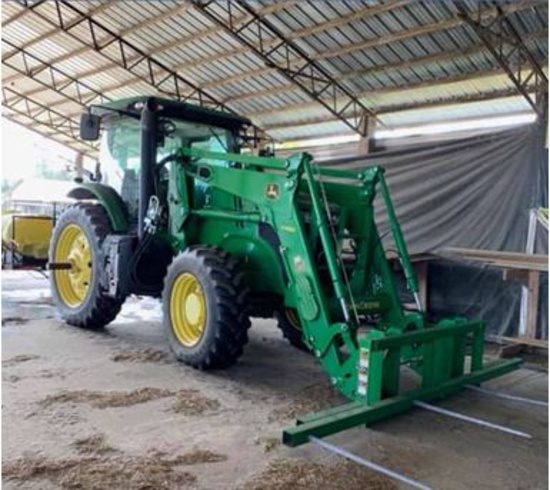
(321, 125), (548, 337)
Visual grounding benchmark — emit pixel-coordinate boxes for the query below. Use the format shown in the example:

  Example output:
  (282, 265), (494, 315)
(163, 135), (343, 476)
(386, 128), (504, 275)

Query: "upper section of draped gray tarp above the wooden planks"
(322, 125), (548, 253)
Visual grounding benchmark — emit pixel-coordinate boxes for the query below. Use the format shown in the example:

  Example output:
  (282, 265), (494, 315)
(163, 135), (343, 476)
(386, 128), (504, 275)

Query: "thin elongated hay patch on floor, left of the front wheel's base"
(41, 388), (174, 408)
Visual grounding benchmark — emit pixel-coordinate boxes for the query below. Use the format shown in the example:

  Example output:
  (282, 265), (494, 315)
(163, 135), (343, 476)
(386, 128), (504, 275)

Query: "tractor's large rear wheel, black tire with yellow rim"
(49, 203), (124, 329)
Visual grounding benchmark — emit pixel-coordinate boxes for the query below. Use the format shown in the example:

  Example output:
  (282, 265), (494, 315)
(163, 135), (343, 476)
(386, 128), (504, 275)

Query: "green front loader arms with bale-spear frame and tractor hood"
(170, 148), (519, 446)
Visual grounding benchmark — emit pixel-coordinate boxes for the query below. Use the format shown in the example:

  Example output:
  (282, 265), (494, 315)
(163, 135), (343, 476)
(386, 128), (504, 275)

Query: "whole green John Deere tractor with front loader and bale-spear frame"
(49, 97), (518, 445)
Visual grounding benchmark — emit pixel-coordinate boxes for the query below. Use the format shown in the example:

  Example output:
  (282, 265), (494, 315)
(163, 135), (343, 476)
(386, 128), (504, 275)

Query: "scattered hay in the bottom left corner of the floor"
(2, 455), (196, 490)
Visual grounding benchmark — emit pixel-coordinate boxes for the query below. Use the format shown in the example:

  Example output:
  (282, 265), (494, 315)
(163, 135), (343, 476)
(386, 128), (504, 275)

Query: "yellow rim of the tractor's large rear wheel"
(54, 224), (92, 308)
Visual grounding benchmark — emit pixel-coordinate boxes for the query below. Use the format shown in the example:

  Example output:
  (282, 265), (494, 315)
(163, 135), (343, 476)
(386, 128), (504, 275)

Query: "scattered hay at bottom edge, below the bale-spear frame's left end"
(238, 459), (397, 490)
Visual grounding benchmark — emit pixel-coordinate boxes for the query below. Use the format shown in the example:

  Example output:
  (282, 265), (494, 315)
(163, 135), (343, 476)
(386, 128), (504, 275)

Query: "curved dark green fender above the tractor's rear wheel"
(67, 182), (128, 233)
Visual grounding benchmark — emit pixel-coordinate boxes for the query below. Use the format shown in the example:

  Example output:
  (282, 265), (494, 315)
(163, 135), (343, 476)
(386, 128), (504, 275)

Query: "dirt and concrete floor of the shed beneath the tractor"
(2, 272), (548, 490)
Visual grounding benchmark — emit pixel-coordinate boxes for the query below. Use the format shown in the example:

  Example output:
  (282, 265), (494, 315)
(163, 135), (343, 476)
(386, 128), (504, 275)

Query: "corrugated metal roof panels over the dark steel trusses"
(2, 0), (548, 155)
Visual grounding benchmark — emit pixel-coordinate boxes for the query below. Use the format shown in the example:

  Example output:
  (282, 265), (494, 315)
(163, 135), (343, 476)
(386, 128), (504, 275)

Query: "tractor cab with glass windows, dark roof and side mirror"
(81, 97), (250, 232)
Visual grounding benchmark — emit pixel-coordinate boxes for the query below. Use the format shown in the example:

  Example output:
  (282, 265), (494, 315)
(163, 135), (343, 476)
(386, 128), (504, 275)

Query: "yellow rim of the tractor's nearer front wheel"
(170, 272), (206, 347)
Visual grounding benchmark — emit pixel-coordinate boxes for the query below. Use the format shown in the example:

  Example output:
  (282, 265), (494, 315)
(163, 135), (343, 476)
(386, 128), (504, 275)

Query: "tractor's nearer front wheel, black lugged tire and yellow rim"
(162, 246), (250, 370)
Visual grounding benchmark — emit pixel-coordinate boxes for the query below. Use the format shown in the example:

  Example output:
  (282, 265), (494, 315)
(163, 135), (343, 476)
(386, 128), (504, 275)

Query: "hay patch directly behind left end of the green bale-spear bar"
(268, 383), (347, 422)
